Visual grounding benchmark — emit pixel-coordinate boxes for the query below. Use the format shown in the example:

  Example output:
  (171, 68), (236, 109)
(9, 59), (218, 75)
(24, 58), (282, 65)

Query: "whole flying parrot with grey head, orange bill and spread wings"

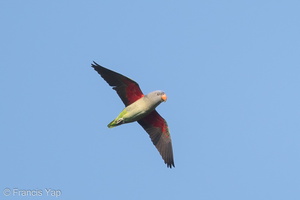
(92, 61), (175, 168)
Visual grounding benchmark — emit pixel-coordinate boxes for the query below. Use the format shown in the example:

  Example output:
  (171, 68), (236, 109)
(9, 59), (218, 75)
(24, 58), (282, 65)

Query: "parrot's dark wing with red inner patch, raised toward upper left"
(92, 62), (144, 106)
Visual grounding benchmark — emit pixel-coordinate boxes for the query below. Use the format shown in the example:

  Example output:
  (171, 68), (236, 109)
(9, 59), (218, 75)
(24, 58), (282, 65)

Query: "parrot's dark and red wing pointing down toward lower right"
(138, 110), (175, 168)
